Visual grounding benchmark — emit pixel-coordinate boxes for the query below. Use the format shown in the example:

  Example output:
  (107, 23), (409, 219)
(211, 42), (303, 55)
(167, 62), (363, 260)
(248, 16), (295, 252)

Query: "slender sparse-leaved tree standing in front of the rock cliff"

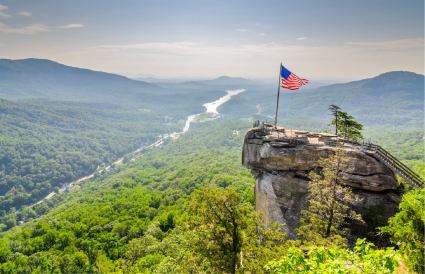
(297, 148), (361, 244)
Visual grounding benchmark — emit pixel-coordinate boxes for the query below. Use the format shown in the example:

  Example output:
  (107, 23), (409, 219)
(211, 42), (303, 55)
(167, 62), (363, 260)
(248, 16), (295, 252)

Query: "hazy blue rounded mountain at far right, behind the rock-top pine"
(305, 71), (424, 118)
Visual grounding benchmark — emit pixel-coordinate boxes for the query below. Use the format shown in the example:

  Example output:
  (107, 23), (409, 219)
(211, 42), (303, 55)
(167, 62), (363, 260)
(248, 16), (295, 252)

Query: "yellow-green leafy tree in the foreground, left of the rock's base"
(189, 188), (283, 273)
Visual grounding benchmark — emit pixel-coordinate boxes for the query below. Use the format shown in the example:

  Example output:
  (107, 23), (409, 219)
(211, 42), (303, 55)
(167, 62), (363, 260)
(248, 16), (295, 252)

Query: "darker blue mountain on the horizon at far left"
(0, 59), (160, 103)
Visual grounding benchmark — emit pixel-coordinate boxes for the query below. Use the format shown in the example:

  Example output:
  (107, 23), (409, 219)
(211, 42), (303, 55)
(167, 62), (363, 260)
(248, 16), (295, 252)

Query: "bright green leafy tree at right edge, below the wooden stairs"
(382, 188), (425, 273)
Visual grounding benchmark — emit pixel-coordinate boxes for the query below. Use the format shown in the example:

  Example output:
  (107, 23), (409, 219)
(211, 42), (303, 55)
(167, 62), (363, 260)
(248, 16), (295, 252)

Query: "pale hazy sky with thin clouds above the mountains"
(0, 0), (424, 80)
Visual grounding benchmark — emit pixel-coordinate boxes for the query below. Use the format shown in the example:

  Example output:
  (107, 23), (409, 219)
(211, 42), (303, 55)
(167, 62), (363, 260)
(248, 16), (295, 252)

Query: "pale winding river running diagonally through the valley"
(32, 89), (245, 206)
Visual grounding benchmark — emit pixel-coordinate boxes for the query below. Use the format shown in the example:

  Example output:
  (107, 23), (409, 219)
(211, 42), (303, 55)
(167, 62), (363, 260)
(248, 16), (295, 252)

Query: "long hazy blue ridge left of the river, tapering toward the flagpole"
(0, 59), (249, 117)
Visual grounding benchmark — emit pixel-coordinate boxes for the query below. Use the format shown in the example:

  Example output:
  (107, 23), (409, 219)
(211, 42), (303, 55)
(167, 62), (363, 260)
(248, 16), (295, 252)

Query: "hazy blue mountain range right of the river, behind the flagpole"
(223, 71), (424, 127)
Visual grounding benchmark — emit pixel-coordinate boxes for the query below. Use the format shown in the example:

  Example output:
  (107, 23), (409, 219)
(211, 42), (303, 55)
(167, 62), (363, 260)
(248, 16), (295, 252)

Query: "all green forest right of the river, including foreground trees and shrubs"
(0, 118), (425, 273)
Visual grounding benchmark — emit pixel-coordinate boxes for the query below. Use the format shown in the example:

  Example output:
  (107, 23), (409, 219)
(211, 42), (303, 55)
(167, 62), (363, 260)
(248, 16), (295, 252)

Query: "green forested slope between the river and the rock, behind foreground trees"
(0, 121), (254, 272)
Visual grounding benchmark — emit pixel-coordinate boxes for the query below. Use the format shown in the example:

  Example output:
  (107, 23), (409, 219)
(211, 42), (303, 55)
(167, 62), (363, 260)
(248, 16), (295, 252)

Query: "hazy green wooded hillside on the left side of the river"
(0, 100), (175, 223)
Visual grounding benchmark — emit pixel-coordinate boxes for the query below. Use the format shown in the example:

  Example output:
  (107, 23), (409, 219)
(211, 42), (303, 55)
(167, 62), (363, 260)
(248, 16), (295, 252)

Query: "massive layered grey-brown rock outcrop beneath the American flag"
(242, 124), (400, 242)
